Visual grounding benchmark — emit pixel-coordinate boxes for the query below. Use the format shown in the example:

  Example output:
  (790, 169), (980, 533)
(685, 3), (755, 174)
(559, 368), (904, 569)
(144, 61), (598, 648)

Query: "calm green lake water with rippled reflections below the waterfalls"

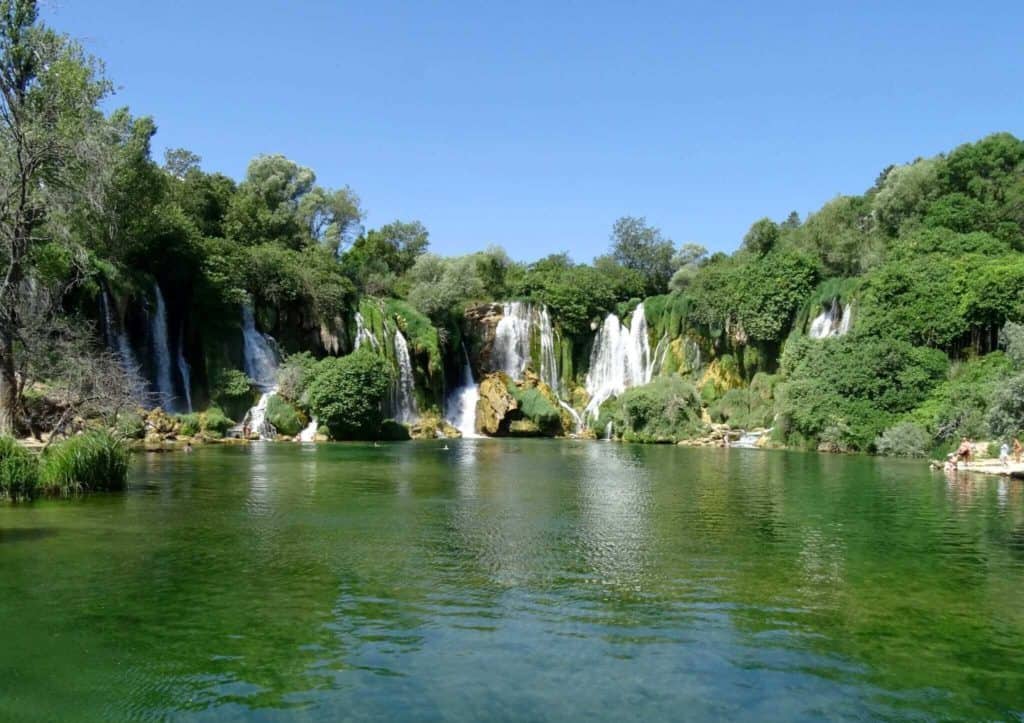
(0, 440), (1024, 720)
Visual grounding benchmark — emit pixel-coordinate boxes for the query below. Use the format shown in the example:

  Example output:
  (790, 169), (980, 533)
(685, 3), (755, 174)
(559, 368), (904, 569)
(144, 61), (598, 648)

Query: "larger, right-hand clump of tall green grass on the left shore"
(40, 429), (128, 497)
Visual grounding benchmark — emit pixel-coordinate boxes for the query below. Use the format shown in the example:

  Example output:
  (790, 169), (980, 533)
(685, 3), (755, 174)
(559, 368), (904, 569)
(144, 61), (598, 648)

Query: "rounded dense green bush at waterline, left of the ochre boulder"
(308, 347), (392, 439)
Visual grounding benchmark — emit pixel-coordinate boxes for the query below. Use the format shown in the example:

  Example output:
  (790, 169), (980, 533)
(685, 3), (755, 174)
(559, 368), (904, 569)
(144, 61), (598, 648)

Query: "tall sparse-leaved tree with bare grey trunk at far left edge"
(0, 0), (111, 433)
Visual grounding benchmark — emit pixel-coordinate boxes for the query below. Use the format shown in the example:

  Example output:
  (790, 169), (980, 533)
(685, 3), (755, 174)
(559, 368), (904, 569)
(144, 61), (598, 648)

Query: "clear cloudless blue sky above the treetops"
(44, 0), (1024, 260)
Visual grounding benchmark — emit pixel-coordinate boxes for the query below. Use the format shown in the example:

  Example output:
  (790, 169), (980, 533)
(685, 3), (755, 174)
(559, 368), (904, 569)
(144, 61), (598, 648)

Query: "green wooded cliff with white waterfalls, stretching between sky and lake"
(0, 2), (1024, 497)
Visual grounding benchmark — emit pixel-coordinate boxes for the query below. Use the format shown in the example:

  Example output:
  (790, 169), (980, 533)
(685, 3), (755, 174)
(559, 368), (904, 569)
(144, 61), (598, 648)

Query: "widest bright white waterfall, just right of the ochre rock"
(584, 304), (653, 418)
